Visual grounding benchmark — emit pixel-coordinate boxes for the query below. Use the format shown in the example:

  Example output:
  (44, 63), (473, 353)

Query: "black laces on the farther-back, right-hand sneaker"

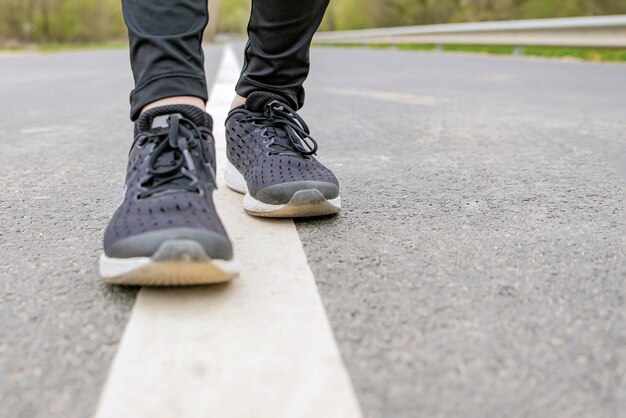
(243, 100), (317, 156)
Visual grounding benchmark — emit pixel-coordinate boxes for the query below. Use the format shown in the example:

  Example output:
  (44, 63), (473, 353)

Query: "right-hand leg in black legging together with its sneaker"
(225, 0), (341, 217)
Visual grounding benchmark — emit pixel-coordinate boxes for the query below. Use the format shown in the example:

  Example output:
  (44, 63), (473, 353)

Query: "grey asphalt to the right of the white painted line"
(297, 48), (626, 418)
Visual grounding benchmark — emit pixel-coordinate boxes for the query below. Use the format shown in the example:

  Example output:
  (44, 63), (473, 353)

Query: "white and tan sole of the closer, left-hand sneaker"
(100, 240), (239, 286)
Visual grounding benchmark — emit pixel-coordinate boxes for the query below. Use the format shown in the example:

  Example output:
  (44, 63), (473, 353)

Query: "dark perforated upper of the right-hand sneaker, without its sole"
(226, 92), (338, 196)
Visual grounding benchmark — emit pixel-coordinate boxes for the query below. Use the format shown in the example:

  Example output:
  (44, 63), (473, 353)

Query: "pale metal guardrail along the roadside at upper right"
(315, 15), (626, 48)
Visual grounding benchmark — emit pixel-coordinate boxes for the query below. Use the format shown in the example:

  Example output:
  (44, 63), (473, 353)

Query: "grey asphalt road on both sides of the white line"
(0, 47), (626, 418)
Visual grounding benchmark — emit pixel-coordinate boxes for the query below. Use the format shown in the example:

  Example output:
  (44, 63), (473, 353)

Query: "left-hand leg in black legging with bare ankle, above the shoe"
(122, 0), (209, 120)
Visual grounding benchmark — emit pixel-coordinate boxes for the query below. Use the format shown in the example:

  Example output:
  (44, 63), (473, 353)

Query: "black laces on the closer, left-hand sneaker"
(137, 115), (216, 199)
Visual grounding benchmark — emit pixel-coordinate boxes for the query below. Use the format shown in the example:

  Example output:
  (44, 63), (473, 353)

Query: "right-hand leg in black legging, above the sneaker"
(234, 0), (329, 110)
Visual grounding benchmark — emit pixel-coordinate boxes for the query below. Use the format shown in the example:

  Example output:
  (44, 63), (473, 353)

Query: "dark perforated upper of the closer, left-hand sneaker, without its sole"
(104, 106), (232, 258)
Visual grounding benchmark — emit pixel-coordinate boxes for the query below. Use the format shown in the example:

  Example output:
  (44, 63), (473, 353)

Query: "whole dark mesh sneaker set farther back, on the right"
(225, 92), (341, 217)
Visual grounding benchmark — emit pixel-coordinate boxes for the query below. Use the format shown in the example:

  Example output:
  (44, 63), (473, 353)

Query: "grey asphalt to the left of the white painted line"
(0, 47), (221, 418)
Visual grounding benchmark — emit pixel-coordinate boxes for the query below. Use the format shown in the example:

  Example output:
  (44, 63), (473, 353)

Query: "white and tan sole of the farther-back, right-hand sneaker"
(224, 161), (341, 218)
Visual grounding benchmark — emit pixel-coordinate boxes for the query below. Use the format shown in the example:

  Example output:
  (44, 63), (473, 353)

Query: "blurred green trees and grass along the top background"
(0, 0), (626, 42)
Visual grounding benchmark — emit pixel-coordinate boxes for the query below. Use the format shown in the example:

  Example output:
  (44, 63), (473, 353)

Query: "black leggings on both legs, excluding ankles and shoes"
(122, 0), (329, 120)
